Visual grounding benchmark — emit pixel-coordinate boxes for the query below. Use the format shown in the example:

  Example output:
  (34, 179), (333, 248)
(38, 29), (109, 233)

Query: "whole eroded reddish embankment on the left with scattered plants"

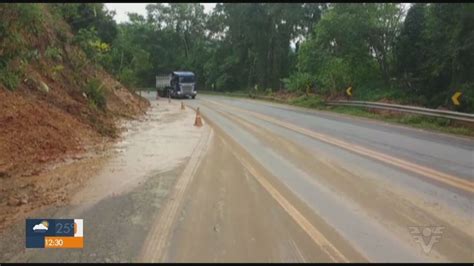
(0, 4), (150, 223)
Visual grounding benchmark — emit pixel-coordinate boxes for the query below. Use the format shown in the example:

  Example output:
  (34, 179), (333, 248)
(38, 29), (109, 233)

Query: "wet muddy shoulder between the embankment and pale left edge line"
(0, 97), (209, 262)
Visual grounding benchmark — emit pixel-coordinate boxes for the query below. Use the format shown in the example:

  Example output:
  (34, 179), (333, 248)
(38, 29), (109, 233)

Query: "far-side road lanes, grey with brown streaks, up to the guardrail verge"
(182, 95), (474, 261)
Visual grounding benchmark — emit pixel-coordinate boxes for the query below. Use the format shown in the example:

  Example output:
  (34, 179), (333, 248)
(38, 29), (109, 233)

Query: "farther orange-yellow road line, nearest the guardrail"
(204, 100), (474, 193)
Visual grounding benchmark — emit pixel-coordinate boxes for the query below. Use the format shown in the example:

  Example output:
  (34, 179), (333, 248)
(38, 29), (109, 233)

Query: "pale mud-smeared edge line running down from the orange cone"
(139, 127), (213, 262)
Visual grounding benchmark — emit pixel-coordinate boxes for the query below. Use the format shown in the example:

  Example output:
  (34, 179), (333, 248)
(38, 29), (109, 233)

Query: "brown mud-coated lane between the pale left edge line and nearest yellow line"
(156, 118), (365, 262)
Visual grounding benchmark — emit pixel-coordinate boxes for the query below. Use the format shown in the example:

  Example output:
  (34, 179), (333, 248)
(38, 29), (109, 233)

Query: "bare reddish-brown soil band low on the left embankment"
(0, 79), (148, 178)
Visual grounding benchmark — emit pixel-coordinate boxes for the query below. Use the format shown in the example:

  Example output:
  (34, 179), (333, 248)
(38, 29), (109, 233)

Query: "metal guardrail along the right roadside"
(326, 100), (474, 123)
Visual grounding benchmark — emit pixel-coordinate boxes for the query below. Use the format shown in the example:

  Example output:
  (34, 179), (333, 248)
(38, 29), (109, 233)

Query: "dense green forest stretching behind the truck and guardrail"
(2, 3), (474, 112)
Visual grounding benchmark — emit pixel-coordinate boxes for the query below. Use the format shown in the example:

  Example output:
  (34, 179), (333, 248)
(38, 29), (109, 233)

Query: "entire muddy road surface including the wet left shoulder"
(0, 93), (474, 262)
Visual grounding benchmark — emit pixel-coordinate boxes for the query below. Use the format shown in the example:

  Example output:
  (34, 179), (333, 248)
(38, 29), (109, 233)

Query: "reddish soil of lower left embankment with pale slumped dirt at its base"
(0, 88), (148, 233)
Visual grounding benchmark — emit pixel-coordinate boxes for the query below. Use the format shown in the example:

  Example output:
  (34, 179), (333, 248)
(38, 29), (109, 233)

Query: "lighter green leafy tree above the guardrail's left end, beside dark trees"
(298, 4), (380, 92)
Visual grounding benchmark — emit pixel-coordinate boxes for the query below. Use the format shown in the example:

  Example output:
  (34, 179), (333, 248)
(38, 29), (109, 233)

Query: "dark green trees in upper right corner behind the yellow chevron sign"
(397, 3), (474, 109)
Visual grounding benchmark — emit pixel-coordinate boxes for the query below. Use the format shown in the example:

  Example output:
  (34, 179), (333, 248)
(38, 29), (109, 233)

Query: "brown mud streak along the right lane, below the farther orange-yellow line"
(200, 101), (473, 261)
